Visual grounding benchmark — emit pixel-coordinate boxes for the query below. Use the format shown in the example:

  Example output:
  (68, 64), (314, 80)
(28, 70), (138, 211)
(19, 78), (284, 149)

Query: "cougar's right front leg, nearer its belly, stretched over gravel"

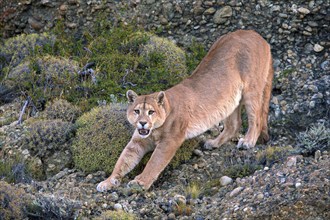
(129, 137), (184, 190)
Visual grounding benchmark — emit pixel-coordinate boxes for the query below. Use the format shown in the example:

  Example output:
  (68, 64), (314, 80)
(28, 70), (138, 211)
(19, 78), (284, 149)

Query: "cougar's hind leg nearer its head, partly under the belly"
(204, 103), (242, 149)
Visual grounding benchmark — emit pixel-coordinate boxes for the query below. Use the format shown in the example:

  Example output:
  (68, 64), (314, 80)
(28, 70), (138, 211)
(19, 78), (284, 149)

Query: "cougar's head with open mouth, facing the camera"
(126, 90), (166, 138)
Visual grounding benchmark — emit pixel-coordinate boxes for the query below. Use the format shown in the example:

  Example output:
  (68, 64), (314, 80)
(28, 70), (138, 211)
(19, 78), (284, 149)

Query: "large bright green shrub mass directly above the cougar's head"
(79, 26), (187, 103)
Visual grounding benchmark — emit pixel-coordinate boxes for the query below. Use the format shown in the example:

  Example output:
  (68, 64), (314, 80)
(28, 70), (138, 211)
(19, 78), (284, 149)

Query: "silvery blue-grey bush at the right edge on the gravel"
(297, 123), (330, 155)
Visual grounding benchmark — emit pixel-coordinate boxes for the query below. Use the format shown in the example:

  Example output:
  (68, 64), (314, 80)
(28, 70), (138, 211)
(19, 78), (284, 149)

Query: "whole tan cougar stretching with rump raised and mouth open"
(97, 30), (273, 191)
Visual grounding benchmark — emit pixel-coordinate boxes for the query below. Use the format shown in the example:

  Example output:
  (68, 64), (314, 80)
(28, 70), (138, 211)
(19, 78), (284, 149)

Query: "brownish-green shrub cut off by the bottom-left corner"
(0, 181), (27, 220)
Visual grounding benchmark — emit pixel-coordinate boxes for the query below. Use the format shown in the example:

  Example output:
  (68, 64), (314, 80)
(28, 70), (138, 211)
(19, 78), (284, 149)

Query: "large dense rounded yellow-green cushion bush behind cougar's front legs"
(72, 103), (133, 174)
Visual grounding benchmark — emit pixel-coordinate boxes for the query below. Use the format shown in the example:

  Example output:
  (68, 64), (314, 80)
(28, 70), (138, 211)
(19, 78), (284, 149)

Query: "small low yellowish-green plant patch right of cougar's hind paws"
(256, 146), (293, 166)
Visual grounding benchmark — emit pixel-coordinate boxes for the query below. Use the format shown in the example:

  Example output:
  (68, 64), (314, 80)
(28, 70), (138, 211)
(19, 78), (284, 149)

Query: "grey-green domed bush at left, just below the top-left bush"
(4, 55), (78, 107)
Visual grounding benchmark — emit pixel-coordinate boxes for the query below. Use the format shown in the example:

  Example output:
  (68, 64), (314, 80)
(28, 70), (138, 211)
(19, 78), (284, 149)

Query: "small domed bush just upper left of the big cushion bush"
(41, 99), (81, 122)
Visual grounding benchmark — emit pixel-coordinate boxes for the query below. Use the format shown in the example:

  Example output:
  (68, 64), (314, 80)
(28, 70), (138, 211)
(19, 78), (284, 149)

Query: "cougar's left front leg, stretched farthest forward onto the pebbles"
(96, 136), (152, 192)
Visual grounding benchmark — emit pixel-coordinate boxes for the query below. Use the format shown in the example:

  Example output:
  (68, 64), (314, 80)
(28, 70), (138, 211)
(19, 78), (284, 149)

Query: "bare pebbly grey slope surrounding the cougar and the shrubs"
(0, 0), (330, 220)
